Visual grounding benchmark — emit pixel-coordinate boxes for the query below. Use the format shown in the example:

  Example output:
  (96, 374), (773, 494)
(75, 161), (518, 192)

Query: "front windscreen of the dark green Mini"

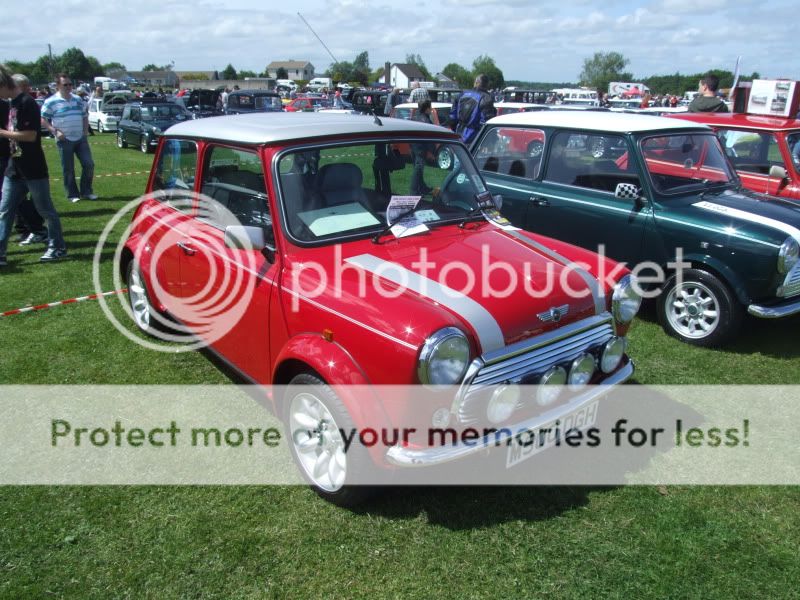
(640, 132), (736, 194)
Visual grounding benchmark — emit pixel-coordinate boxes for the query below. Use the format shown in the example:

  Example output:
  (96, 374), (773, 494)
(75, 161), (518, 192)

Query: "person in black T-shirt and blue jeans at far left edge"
(0, 64), (67, 267)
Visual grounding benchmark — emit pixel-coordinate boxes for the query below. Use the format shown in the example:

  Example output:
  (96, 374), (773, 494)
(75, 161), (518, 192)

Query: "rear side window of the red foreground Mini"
(153, 139), (197, 212)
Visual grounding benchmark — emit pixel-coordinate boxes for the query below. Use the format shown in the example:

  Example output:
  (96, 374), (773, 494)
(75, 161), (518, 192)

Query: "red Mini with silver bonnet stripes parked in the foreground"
(119, 113), (640, 504)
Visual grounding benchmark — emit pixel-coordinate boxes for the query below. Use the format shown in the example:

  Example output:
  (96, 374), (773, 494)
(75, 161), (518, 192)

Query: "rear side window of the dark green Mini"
(475, 127), (545, 179)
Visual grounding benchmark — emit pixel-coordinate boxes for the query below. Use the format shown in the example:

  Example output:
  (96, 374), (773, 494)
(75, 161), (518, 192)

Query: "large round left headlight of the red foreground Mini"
(417, 327), (469, 386)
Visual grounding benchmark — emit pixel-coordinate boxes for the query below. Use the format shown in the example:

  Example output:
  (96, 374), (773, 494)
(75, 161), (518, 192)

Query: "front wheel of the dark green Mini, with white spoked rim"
(658, 269), (743, 347)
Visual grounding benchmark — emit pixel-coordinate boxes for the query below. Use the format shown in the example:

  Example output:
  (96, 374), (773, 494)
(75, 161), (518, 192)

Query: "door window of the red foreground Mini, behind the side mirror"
(198, 146), (272, 233)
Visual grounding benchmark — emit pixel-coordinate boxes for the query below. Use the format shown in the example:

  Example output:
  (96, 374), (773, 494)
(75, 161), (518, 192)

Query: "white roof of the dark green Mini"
(487, 110), (710, 133)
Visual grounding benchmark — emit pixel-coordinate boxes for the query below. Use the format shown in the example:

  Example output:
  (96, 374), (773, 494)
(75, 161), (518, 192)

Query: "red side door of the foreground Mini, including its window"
(181, 146), (278, 382)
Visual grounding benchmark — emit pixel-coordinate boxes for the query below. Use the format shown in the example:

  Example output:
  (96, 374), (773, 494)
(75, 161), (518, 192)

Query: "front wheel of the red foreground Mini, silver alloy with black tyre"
(283, 373), (375, 506)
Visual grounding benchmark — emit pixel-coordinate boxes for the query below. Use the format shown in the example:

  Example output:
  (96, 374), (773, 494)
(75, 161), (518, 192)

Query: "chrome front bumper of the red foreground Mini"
(386, 359), (634, 467)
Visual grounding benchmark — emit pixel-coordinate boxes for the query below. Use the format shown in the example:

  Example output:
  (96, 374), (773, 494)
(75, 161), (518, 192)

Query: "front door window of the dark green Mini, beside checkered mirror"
(544, 131), (641, 194)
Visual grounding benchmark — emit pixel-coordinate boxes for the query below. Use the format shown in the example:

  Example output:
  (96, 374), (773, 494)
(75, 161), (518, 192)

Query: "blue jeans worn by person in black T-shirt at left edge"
(0, 177), (66, 256)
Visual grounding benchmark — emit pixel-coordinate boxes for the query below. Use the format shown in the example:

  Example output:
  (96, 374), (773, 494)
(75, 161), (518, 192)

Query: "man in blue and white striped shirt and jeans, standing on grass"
(42, 73), (97, 202)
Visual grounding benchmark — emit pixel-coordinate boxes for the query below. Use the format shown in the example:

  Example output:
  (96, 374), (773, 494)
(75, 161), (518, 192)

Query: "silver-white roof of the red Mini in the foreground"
(164, 112), (454, 144)
